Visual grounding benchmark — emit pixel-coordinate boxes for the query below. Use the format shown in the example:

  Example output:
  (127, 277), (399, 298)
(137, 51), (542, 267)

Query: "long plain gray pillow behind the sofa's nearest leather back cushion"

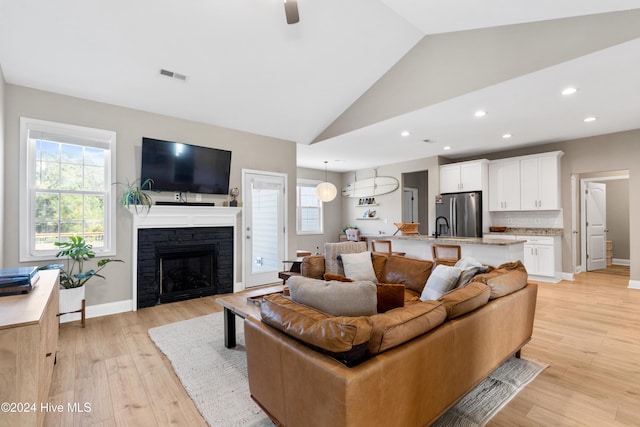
(287, 276), (377, 316)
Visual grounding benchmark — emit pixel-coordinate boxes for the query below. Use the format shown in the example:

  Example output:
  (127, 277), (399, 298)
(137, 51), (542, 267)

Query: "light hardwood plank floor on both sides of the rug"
(45, 273), (640, 426)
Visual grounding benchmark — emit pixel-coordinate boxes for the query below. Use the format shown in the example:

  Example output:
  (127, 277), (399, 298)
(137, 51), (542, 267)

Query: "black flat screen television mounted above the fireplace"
(140, 138), (231, 194)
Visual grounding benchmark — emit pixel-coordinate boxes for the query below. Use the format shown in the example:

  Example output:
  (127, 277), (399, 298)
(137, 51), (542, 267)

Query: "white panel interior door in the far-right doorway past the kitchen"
(585, 182), (607, 271)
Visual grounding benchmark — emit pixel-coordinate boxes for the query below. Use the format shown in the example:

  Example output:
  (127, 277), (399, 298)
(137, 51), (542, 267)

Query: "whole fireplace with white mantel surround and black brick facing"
(129, 205), (242, 311)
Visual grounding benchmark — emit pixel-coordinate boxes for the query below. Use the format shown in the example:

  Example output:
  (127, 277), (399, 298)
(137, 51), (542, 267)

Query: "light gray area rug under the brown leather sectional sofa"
(149, 313), (547, 427)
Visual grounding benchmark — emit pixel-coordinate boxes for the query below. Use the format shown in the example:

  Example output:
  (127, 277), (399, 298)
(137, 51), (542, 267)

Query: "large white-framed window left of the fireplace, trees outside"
(20, 117), (116, 262)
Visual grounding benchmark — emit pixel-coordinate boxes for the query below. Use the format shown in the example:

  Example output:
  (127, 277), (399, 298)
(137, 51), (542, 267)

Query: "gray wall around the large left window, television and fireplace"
(0, 84), (296, 306)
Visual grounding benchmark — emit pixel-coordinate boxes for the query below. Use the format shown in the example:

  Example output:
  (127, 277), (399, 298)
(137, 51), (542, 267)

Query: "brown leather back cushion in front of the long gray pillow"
(260, 294), (372, 366)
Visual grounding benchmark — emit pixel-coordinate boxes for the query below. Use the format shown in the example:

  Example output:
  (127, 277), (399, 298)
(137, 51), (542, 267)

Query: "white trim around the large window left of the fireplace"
(19, 117), (116, 262)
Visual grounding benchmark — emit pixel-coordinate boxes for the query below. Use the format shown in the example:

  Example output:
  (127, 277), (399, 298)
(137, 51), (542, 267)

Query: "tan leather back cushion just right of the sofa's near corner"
(369, 301), (447, 355)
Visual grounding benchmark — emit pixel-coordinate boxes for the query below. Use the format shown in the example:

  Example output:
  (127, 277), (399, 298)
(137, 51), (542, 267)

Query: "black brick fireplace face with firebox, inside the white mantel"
(137, 227), (233, 308)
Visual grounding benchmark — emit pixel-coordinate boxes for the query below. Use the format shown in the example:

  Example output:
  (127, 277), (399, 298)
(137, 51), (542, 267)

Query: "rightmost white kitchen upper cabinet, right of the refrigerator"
(520, 152), (561, 211)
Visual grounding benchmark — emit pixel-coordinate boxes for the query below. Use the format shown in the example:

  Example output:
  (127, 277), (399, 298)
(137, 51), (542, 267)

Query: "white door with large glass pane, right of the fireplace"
(243, 171), (286, 287)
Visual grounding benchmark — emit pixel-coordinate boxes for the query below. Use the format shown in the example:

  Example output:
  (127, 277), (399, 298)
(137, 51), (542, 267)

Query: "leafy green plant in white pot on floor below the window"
(47, 236), (124, 327)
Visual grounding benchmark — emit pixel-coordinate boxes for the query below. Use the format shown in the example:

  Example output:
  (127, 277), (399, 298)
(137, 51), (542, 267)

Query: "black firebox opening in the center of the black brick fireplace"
(156, 245), (216, 304)
